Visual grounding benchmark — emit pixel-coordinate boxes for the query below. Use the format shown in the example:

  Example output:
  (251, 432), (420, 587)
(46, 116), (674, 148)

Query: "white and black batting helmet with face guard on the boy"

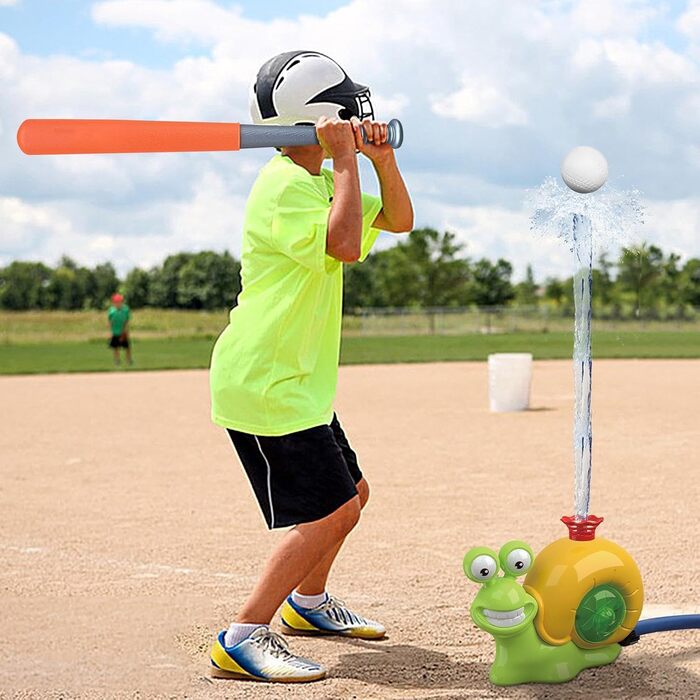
(250, 51), (374, 126)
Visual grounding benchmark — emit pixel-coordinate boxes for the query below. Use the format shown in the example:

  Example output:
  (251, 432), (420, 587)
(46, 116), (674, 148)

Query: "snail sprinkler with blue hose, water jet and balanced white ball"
(463, 146), (700, 685)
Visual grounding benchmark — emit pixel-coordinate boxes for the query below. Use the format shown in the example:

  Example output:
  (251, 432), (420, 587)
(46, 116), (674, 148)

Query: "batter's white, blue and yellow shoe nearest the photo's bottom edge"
(211, 625), (326, 683)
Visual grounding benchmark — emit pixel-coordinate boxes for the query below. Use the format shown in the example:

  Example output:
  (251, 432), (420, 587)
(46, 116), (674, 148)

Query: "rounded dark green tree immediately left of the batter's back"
(177, 251), (241, 309)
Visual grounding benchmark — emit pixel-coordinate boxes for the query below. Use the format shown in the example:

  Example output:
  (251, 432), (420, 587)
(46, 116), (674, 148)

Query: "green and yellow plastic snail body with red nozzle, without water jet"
(464, 516), (644, 685)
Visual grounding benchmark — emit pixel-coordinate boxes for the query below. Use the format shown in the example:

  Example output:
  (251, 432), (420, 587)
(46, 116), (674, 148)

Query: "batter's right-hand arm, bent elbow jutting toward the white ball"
(352, 118), (413, 233)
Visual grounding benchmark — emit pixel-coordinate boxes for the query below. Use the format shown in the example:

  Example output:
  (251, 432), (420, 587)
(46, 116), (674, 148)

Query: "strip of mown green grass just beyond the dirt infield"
(0, 331), (700, 374)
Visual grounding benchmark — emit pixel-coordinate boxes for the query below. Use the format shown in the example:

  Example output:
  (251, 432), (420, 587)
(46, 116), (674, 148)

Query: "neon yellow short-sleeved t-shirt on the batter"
(210, 155), (382, 435)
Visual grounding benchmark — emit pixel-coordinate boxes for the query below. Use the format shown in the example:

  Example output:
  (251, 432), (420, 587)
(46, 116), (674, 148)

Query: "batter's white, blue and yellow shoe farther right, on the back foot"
(280, 595), (386, 639)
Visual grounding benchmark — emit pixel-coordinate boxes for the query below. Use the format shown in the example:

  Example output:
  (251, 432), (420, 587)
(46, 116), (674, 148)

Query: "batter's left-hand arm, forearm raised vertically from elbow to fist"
(316, 117), (362, 262)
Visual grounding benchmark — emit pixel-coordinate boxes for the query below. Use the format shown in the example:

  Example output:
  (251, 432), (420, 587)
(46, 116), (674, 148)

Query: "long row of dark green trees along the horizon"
(0, 228), (700, 317)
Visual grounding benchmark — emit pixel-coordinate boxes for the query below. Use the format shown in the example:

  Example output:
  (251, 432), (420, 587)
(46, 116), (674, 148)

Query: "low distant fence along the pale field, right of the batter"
(343, 306), (700, 335)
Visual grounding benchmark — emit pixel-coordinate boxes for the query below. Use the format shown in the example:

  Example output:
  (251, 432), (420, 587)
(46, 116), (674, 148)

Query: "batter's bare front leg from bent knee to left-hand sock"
(236, 496), (361, 624)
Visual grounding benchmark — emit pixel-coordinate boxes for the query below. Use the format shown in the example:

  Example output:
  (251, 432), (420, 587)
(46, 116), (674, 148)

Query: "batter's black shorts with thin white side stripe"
(227, 415), (362, 529)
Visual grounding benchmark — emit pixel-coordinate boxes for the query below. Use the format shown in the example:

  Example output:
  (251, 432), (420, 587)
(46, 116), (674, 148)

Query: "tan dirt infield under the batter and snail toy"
(0, 361), (700, 700)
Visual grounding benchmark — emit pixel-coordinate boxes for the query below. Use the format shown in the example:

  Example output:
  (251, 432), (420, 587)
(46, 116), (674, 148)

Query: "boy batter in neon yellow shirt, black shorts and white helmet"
(210, 51), (413, 682)
